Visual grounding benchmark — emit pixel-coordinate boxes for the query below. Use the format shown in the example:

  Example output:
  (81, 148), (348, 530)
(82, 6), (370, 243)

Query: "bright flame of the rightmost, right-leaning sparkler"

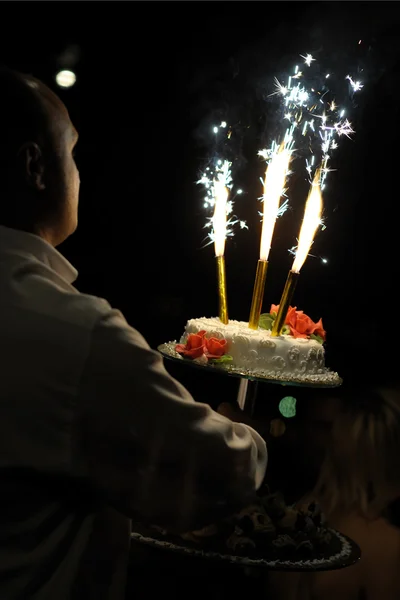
(292, 169), (322, 273)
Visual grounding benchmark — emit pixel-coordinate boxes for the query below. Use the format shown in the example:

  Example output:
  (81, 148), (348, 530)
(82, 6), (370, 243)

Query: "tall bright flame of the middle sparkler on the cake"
(260, 144), (290, 261)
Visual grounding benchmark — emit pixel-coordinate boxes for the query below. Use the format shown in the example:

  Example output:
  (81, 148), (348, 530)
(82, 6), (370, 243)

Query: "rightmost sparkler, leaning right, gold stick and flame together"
(271, 169), (322, 337)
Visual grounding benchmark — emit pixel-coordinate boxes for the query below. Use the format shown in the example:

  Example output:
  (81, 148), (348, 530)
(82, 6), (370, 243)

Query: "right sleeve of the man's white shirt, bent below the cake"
(79, 311), (267, 530)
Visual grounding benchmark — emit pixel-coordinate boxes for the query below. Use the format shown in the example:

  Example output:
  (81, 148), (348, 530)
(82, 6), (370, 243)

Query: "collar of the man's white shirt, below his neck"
(0, 225), (78, 283)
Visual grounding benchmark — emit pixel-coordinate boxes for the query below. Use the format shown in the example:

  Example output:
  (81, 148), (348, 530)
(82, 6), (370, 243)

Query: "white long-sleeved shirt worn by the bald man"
(0, 226), (267, 600)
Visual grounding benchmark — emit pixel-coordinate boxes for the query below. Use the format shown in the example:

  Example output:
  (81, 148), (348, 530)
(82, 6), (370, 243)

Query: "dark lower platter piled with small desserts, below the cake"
(133, 488), (360, 570)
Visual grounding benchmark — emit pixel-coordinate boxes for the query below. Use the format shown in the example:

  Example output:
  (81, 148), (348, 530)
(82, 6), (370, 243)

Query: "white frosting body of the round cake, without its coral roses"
(177, 317), (340, 385)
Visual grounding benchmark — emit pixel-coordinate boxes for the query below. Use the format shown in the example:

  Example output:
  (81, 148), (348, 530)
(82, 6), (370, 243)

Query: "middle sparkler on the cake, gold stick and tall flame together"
(249, 144), (290, 329)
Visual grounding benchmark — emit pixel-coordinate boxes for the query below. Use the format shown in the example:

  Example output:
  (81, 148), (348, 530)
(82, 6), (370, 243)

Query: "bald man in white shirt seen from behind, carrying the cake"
(0, 70), (267, 600)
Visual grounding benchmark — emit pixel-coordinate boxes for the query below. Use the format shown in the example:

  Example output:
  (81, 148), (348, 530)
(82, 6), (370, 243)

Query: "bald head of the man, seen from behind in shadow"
(0, 69), (79, 244)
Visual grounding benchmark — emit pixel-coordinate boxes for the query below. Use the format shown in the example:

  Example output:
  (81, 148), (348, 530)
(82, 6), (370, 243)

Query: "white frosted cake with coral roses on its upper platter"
(163, 305), (341, 386)
